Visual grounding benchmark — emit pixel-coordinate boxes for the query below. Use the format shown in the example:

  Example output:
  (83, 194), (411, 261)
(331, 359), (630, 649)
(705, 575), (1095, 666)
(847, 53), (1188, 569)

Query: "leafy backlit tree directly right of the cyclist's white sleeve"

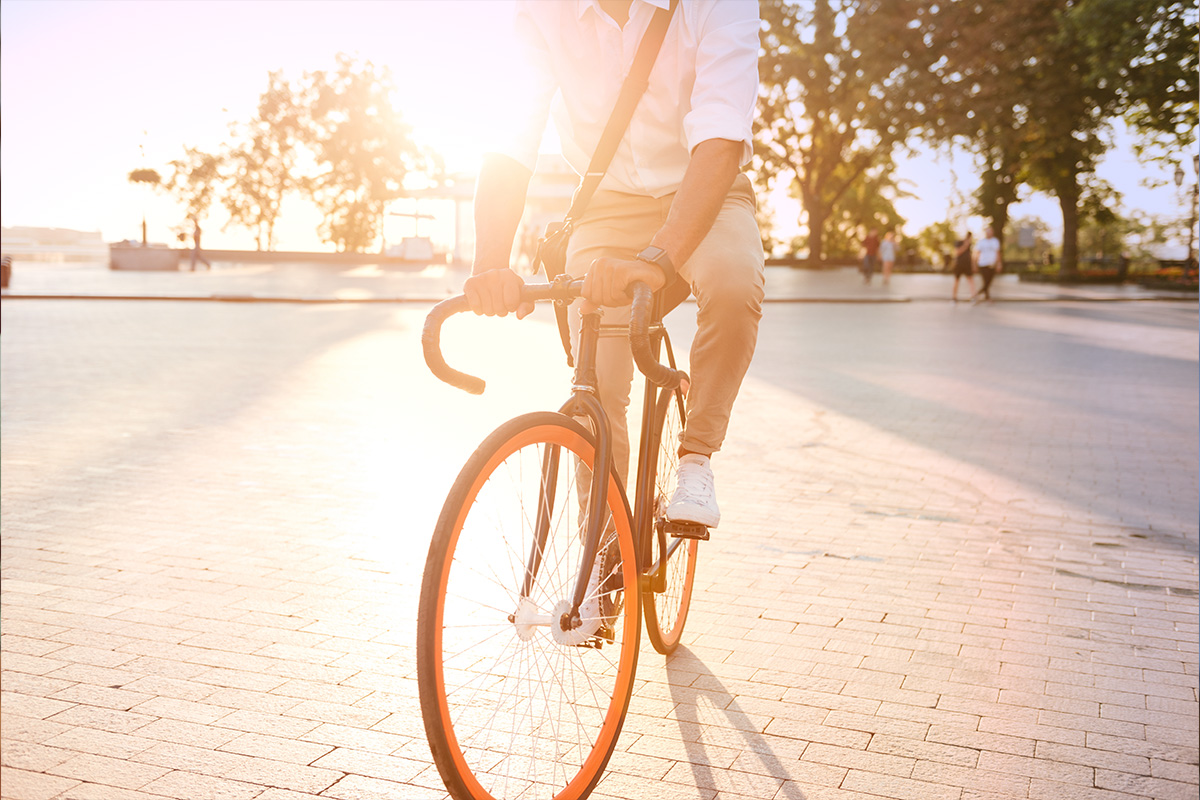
(755, 0), (924, 261)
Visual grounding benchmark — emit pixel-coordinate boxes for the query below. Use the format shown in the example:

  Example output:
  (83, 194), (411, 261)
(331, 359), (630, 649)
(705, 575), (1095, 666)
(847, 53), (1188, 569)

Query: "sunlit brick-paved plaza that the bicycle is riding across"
(0, 293), (1200, 800)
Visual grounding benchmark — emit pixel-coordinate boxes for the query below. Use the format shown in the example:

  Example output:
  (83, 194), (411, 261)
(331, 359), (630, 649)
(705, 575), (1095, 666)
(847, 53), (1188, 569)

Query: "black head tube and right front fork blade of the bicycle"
(559, 304), (612, 631)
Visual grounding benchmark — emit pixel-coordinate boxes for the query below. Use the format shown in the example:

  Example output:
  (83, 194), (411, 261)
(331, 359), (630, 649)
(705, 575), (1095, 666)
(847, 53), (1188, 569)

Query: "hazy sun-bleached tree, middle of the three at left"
(221, 71), (305, 249)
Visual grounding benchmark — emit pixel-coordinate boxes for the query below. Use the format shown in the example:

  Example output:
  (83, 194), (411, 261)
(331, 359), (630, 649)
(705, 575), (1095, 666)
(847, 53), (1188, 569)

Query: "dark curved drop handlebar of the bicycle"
(421, 281), (686, 395)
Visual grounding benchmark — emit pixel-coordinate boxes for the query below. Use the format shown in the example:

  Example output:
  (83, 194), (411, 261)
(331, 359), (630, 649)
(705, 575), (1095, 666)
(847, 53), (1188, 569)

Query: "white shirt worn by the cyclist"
(498, 0), (760, 197)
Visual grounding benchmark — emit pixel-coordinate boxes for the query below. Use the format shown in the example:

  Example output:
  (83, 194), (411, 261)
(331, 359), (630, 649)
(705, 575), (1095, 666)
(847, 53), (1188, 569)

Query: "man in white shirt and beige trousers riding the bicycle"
(463, 0), (763, 537)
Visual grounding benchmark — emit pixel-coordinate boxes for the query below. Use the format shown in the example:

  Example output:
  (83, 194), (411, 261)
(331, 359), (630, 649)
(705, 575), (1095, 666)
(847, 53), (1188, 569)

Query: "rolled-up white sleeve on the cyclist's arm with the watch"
(683, 0), (760, 164)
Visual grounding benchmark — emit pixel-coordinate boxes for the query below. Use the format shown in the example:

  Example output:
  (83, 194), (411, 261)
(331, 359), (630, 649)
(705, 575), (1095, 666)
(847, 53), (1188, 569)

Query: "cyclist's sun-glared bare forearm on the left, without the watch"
(470, 155), (530, 275)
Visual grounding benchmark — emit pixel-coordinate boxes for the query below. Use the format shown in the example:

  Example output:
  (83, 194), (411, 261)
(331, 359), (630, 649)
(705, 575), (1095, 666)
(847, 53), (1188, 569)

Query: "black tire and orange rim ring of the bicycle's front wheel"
(416, 411), (641, 800)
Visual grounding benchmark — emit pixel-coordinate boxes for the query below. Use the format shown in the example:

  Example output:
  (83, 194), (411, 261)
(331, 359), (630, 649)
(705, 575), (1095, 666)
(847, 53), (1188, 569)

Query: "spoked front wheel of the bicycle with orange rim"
(416, 413), (641, 800)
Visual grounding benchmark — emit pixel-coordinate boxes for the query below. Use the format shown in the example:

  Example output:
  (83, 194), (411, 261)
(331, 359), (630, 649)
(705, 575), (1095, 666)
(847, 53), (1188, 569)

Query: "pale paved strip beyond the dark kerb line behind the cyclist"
(4, 261), (1196, 302)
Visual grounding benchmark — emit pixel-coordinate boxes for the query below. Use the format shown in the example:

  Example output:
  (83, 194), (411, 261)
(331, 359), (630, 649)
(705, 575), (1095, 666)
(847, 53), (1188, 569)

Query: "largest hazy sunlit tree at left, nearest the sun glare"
(302, 54), (419, 252)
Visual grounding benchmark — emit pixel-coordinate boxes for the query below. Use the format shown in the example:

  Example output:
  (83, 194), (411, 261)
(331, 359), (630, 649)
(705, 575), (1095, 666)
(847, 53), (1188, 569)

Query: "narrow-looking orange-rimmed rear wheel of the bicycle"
(642, 389), (700, 655)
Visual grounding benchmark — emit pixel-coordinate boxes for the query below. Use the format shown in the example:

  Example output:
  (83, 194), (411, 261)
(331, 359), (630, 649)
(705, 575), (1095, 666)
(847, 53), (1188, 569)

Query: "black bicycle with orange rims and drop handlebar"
(416, 276), (708, 800)
